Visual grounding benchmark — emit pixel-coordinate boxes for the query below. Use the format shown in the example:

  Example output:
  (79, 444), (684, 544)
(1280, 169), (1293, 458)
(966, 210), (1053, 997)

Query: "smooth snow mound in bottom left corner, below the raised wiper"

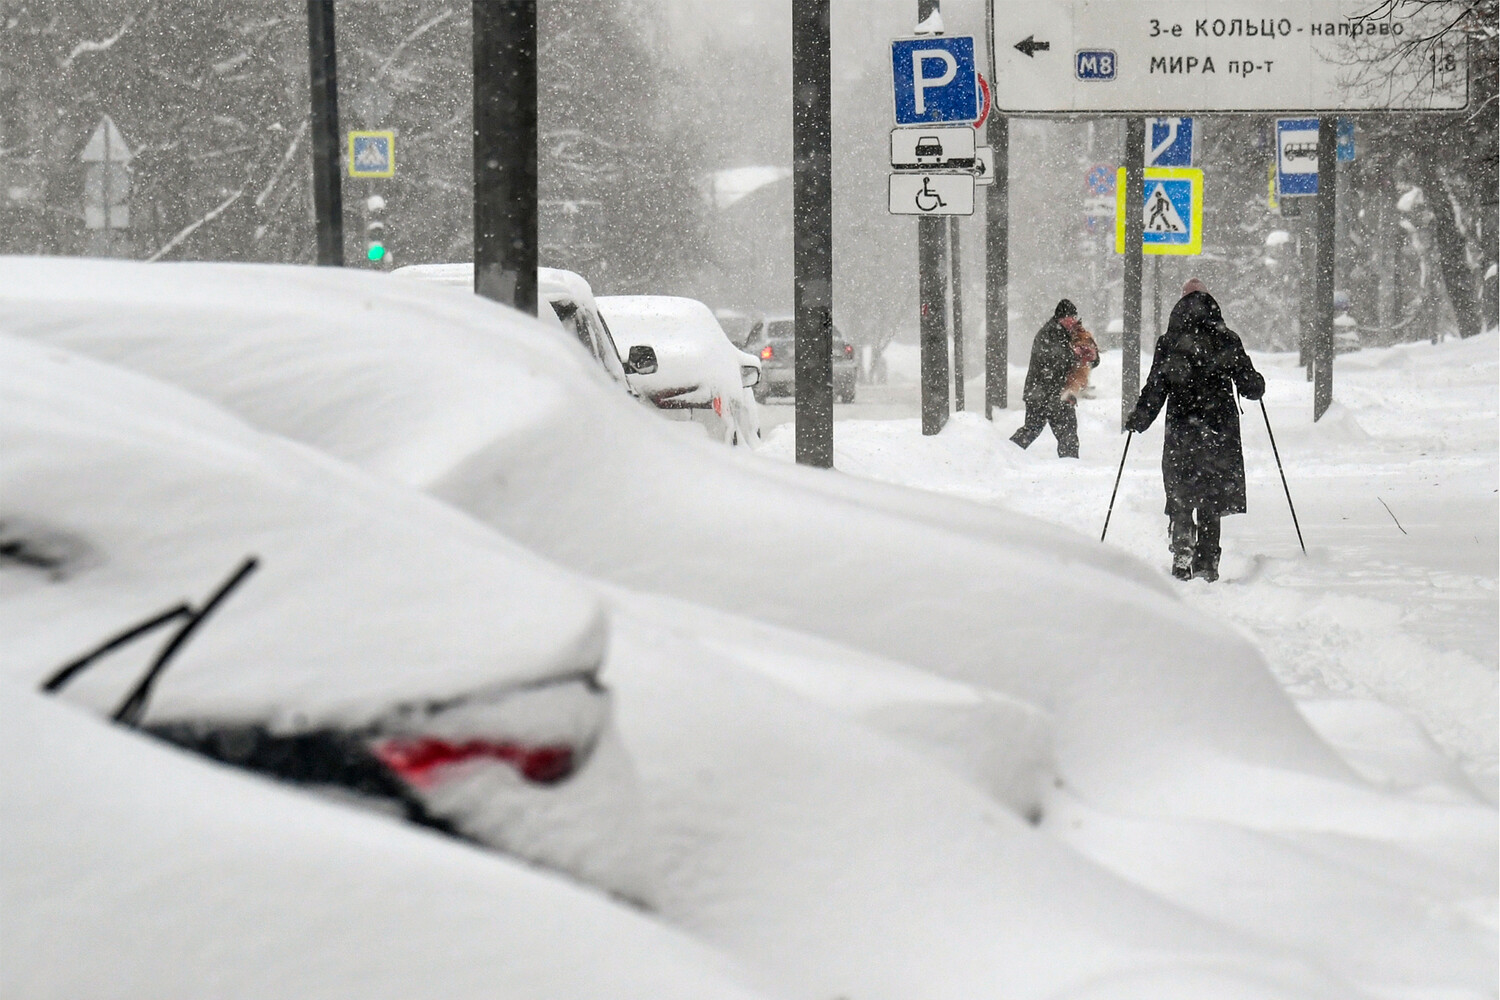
(0, 679), (764, 1000)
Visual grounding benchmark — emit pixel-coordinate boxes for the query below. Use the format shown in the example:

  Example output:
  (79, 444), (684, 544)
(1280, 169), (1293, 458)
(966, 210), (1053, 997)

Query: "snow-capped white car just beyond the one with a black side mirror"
(599, 295), (761, 444)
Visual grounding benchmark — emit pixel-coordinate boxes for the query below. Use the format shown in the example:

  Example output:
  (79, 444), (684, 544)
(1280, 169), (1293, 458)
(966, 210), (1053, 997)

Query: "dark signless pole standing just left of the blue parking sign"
(792, 0), (834, 469)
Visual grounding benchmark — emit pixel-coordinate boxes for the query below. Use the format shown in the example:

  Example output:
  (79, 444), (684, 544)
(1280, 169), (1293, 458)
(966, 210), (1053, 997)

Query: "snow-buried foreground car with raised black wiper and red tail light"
(0, 336), (638, 892)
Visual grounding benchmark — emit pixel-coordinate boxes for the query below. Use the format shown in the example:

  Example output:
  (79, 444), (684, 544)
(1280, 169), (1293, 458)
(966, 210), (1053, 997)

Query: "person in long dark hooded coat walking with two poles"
(1125, 279), (1266, 582)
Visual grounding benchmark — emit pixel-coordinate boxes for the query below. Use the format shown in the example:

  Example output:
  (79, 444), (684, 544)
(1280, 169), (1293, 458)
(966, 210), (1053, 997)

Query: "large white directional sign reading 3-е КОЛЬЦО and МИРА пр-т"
(990, 0), (1469, 114)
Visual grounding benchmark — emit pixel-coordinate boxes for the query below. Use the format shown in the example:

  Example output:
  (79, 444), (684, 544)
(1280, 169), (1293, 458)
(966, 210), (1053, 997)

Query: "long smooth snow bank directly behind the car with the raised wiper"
(0, 258), (1352, 814)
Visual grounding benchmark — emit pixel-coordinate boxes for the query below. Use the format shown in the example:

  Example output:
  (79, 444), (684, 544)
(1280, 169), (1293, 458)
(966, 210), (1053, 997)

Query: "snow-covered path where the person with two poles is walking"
(761, 333), (1500, 801)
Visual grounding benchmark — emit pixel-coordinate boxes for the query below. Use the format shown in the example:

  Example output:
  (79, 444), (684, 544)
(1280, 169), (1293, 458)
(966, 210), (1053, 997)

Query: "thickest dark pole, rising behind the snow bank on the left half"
(474, 0), (537, 315)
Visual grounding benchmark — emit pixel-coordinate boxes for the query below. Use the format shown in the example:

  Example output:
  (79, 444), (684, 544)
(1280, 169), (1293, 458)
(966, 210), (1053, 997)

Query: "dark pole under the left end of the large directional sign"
(984, 0), (1011, 420)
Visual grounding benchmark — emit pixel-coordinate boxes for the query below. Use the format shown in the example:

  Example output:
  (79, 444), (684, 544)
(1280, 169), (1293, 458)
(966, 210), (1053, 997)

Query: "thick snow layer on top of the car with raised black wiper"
(0, 336), (605, 726)
